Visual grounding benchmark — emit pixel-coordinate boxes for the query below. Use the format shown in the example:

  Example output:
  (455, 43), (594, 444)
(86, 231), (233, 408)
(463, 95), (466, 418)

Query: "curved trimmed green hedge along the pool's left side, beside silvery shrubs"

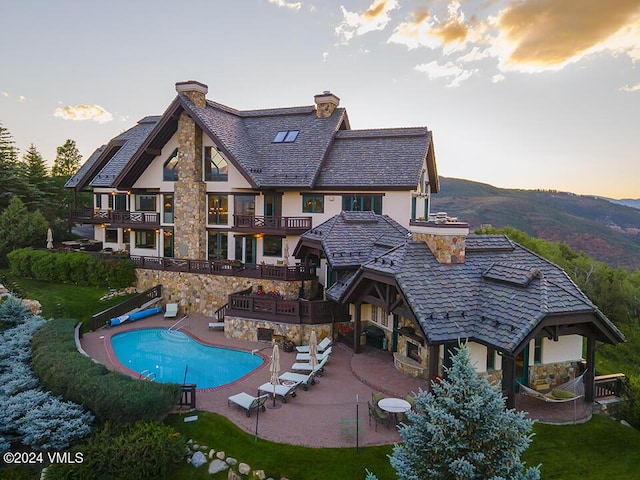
(32, 319), (181, 422)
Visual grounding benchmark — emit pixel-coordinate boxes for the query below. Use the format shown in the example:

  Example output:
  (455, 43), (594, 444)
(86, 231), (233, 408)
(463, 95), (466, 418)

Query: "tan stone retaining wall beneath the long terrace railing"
(136, 268), (302, 316)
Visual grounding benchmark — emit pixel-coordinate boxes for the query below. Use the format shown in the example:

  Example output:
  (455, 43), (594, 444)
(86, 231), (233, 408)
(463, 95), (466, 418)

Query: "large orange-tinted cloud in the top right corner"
(493, 0), (640, 72)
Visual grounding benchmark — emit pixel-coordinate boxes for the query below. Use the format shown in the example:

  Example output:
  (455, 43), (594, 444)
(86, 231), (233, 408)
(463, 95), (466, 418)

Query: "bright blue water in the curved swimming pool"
(111, 328), (264, 388)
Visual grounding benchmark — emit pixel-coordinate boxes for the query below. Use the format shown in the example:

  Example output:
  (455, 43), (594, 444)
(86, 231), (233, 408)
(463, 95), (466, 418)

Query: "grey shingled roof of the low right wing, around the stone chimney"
(320, 218), (624, 352)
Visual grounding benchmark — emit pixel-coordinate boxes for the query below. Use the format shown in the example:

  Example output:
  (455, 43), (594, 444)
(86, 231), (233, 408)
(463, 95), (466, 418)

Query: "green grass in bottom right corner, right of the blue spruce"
(523, 415), (640, 480)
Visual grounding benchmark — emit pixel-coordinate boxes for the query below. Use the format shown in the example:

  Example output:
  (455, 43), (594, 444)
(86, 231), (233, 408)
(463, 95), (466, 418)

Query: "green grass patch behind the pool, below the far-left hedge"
(0, 270), (131, 323)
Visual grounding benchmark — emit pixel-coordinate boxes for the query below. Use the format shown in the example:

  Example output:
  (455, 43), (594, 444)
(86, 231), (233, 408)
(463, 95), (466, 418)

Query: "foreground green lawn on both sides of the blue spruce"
(167, 412), (640, 480)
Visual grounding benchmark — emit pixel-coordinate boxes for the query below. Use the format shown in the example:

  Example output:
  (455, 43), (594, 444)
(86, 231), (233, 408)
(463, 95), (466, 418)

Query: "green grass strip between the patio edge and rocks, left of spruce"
(166, 411), (396, 480)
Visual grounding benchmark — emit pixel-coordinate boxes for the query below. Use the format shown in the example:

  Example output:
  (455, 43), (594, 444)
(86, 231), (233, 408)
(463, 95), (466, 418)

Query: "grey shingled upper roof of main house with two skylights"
(67, 83), (438, 192)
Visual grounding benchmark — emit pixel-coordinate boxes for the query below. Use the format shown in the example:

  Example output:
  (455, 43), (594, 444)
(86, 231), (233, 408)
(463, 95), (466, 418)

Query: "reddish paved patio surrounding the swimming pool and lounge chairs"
(81, 315), (592, 447)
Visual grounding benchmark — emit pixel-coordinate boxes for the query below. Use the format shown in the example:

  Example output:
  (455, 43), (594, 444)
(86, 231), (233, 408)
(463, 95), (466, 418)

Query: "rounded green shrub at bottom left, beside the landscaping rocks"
(47, 422), (185, 480)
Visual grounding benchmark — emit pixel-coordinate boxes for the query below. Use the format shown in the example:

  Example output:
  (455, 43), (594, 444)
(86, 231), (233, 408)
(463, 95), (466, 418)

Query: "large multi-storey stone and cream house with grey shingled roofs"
(66, 81), (623, 403)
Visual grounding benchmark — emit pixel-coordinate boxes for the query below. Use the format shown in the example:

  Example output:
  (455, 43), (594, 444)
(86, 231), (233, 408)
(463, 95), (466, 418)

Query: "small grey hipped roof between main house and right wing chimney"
(294, 212), (407, 270)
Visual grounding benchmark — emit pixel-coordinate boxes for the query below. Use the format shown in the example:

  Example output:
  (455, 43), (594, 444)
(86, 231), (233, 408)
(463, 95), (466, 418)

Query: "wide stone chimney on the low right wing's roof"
(409, 212), (469, 264)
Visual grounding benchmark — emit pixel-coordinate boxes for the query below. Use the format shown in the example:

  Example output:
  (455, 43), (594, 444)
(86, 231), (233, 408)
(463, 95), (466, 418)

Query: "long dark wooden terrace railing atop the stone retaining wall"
(130, 255), (316, 280)
